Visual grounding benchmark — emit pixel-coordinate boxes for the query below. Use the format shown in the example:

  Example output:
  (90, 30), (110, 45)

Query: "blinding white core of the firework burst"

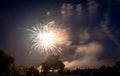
(38, 32), (54, 46)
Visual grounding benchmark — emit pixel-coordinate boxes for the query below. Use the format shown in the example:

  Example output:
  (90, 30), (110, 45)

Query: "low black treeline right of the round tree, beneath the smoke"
(64, 62), (120, 76)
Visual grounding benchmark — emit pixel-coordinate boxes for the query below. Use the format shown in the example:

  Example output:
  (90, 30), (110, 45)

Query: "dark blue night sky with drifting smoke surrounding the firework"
(0, 0), (120, 68)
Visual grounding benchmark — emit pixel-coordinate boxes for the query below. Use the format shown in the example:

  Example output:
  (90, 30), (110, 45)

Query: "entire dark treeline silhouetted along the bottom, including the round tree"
(0, 50), (120, 76)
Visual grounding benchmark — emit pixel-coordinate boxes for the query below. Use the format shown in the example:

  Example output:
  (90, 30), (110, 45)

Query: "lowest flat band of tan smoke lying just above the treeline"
(64, 58), (109, 70)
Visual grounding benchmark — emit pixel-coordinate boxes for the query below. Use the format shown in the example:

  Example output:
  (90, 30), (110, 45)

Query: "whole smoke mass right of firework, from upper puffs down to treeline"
(43, 0), (119, 69)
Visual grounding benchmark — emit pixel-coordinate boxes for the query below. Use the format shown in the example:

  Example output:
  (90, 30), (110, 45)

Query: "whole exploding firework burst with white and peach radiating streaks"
(28, 21), (69, 55)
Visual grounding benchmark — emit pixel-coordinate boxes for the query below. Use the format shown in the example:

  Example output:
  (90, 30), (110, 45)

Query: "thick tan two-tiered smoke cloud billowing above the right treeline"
(64, 41), (106, 69)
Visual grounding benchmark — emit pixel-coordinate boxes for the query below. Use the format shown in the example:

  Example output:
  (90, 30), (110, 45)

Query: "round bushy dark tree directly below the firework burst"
(42, 55), (65, 73)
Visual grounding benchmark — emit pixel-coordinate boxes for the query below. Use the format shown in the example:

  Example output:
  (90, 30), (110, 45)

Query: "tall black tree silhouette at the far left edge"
(0, 50), (14, 76)
